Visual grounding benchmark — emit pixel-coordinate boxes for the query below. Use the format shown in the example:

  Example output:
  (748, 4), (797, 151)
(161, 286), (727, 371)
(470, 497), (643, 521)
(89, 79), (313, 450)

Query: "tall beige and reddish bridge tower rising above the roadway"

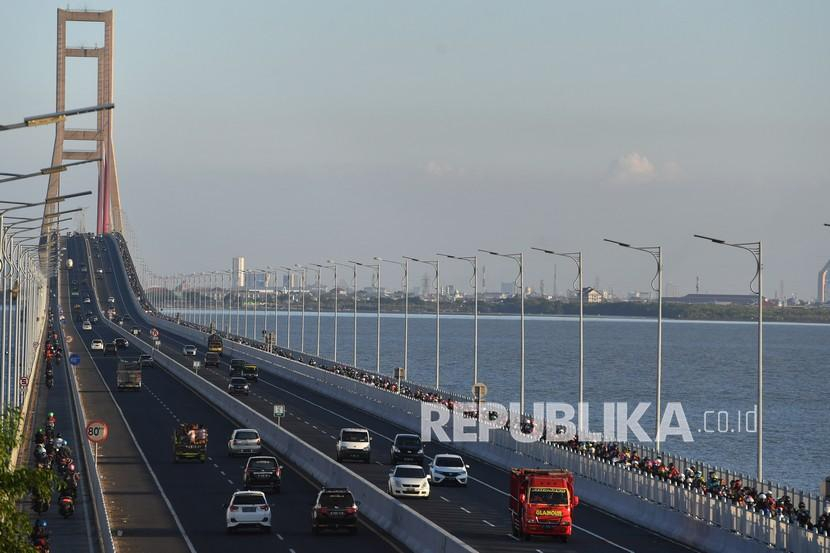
(41, 9), (123, 234)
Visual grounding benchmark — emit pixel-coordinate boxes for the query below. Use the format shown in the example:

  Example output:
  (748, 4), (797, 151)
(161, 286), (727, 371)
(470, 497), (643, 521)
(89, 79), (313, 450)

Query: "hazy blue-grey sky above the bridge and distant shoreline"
(0, 0), (830, 299)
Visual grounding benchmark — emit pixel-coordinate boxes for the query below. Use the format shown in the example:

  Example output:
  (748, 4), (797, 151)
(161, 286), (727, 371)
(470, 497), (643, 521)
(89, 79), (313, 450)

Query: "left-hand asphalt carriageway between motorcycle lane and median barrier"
(65, 237), (404, 553)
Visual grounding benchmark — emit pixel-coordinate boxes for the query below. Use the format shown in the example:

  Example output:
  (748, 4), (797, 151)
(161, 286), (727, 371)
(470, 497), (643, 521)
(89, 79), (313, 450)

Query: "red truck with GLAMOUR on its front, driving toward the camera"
(510, 468), (579, 543)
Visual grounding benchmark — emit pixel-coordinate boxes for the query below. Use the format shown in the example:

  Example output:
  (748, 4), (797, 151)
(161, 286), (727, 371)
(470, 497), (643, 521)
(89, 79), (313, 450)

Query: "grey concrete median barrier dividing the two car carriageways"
(106, 298), (475, 553)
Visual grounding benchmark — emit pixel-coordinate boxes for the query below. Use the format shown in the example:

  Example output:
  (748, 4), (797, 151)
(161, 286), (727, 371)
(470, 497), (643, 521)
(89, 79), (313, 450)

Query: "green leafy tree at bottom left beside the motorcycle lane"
(0, 409), (55, 553)
